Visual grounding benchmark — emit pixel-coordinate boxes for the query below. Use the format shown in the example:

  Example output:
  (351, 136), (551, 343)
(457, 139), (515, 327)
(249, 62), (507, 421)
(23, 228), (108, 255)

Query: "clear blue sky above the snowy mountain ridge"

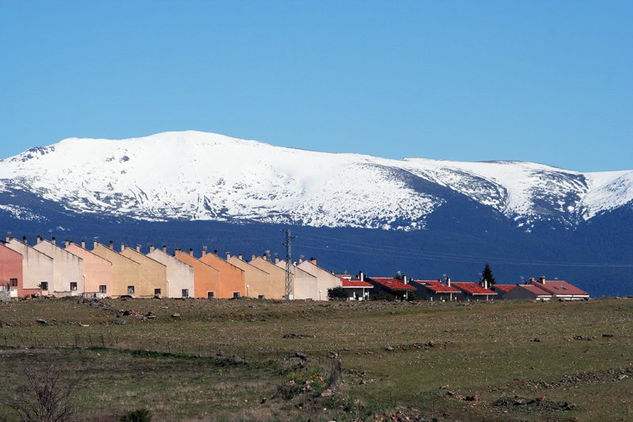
(0, 0), (633, 170)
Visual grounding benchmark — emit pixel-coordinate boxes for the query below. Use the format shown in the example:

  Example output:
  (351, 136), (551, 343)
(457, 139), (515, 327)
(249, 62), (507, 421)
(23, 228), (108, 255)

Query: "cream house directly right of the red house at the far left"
(5, 238), (54, 295)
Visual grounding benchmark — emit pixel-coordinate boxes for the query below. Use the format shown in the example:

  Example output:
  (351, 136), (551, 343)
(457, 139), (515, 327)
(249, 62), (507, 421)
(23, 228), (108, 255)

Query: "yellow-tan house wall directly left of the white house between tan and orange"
(121, 245), (167, 297)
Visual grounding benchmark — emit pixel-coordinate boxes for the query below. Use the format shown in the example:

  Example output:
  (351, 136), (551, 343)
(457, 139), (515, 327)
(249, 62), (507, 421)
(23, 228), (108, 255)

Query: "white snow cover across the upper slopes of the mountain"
(0, 131), (633, 230)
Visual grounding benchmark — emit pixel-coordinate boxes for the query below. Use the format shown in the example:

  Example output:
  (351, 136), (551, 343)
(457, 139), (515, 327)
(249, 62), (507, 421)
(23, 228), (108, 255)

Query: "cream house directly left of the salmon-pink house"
(33, 237), (85, 296)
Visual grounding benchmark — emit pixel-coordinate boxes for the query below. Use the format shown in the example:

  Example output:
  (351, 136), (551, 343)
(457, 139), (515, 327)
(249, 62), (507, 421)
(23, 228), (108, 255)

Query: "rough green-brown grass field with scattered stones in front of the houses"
(0, 299), (633, 421)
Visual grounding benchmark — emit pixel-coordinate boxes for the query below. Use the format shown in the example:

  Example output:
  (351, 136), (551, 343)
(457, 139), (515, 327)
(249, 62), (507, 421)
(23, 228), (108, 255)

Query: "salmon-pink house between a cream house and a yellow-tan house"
(65, 242), (114, 298)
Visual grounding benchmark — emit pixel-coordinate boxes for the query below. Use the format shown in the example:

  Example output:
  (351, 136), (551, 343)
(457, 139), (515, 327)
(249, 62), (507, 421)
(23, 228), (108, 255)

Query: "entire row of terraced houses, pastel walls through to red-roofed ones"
(0, 236), (589, 301)
